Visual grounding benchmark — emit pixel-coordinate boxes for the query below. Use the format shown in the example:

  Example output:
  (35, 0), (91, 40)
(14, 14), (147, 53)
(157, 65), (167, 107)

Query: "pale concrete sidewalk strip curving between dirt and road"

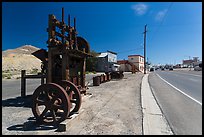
(141, 74), (173, 135)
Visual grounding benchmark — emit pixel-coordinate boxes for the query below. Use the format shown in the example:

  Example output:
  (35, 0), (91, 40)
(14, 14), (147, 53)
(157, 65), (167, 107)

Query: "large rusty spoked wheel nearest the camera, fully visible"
(32, 83), (70, 125)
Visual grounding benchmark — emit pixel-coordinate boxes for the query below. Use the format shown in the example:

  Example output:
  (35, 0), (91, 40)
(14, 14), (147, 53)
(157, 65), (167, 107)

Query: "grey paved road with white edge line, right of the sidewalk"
(149, 70), (202, 135)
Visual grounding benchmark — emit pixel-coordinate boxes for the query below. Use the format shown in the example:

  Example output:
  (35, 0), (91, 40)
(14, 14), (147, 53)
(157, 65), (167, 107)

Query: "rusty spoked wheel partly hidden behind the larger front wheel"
(58, 80), (82, 114)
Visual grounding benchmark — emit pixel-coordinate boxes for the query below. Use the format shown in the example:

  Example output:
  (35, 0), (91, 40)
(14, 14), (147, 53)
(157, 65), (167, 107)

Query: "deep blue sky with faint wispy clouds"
(2, 2), (202, 64)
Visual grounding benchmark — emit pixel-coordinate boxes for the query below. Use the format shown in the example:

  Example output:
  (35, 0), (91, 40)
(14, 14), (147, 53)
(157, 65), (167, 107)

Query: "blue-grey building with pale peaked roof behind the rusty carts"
(96, 50), (120, 72)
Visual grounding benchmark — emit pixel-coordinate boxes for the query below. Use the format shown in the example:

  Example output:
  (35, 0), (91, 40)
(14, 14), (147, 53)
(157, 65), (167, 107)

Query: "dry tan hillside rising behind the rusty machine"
(2, 45), (41, 78)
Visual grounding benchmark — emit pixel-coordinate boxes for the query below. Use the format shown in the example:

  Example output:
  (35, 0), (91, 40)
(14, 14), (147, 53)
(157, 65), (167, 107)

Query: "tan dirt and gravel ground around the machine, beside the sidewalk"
(2, 73), (144, 135)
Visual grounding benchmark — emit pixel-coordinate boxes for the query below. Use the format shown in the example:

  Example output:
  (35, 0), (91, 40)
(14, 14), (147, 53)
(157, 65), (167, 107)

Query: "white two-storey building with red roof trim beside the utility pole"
(128, 55), (144, 73)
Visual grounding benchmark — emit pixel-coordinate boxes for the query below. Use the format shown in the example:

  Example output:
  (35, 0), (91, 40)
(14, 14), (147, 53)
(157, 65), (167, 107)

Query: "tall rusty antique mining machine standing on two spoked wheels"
(32, 8), (91, 125)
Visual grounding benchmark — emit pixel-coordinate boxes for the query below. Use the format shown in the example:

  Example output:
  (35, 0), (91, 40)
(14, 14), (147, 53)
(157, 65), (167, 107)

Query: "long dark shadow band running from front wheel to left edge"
(2, 95), (32, 108)
